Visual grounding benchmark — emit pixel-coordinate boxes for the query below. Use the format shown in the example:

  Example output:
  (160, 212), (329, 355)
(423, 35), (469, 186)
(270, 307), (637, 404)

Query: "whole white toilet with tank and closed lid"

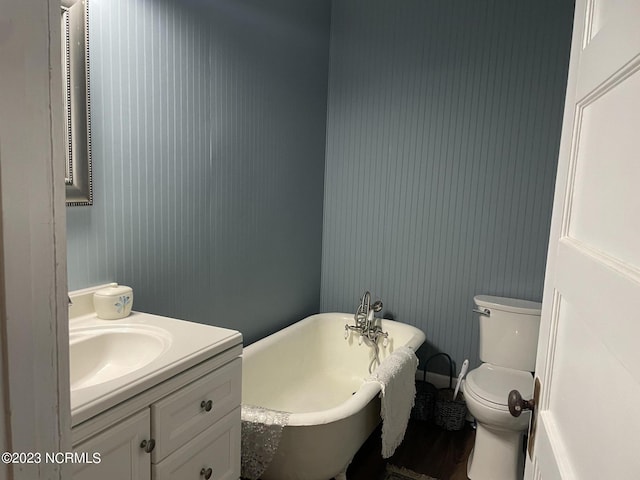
(463, 295), (542, 480)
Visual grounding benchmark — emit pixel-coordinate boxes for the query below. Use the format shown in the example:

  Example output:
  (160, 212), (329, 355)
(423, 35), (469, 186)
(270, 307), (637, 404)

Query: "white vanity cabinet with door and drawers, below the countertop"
(72, 345), (242, 480)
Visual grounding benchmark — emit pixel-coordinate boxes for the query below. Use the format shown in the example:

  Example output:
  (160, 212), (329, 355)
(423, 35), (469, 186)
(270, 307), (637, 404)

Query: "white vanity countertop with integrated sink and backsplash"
(69, 308), (242, 426)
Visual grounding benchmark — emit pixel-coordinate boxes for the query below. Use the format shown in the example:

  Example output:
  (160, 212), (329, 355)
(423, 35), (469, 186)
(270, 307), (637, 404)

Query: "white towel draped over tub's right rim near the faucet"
(367, 347), (418, 458)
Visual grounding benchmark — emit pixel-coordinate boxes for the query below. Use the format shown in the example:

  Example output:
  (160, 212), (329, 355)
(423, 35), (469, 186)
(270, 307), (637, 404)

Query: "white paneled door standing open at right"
(525, 0), (640, 480)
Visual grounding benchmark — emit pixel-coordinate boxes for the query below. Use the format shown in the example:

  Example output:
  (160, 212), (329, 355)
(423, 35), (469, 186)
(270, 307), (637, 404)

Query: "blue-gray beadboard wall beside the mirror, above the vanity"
(67, 0), (330, 341)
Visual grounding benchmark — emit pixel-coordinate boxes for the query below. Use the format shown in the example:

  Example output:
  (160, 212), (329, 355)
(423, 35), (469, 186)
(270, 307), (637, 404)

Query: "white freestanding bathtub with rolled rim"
(242, 313), (425, 480)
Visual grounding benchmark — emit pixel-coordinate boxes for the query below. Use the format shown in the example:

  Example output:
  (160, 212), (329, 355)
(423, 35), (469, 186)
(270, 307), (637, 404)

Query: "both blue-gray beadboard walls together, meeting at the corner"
(67, 0), (573, 362)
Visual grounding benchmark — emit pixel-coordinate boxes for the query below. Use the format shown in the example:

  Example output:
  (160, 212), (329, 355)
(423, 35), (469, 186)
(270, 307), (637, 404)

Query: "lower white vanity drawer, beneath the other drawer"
(152, 407), (240, 480)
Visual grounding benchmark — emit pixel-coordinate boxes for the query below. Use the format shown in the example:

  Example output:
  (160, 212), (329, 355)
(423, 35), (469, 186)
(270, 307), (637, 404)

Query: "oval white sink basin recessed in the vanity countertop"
(69, 324), (171, 392)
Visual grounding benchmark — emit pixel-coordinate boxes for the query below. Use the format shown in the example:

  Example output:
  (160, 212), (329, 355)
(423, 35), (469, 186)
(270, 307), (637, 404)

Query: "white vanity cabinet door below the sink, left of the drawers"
(73, 409), (151, 480)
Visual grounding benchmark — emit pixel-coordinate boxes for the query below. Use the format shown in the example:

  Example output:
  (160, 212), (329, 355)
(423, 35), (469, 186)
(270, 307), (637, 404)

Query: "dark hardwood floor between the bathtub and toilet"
(347, 420), (475, 480)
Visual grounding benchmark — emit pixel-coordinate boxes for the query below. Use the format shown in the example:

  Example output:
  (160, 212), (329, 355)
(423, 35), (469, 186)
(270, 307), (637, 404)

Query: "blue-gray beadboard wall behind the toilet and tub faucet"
(321, 0), (573, 364)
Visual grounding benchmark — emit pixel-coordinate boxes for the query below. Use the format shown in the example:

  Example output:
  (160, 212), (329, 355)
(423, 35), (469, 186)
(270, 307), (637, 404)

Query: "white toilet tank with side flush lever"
(473, 295), (542, 372)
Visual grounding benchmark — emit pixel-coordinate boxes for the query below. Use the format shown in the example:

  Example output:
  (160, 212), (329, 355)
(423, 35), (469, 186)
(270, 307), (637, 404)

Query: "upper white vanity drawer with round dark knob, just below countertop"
(151, 358), (242, 463)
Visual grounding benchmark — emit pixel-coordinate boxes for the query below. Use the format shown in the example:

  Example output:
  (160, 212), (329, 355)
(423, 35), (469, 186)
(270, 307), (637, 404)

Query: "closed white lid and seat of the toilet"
(465, 363), (533, 406)
